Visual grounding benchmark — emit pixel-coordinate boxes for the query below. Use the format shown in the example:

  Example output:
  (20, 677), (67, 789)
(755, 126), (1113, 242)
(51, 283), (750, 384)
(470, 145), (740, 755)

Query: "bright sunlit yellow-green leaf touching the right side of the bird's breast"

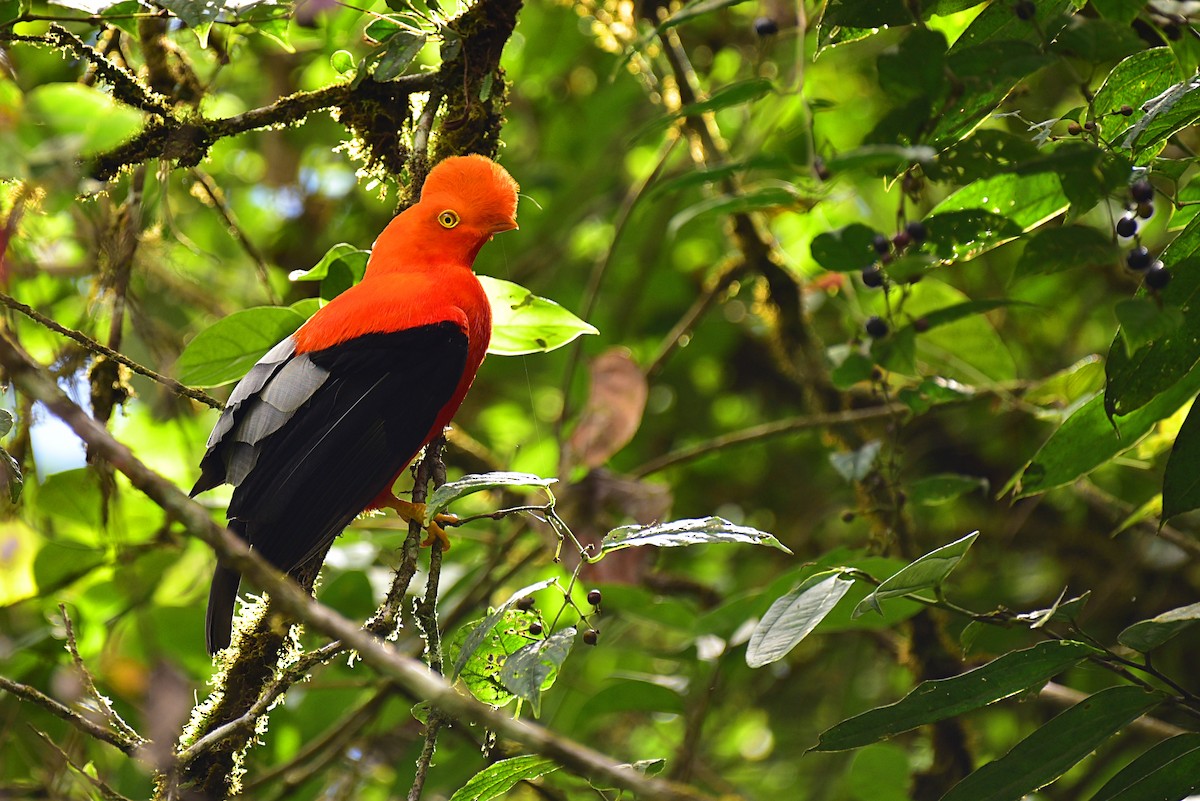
(479, 276), (600, 356)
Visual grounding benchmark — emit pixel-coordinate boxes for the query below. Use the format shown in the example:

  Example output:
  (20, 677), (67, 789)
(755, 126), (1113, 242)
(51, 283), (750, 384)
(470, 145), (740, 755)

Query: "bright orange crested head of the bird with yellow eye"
(418, 156), (520, 245)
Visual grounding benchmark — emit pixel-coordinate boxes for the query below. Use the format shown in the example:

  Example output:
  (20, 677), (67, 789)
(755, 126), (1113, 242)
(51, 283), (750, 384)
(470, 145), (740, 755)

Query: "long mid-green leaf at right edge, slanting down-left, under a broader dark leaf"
(1014, 369), (1200, 498)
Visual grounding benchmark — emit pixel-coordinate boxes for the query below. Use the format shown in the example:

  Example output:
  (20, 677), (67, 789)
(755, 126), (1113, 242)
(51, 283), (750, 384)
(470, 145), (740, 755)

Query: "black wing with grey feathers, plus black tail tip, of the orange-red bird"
(192, 323), (467, 651)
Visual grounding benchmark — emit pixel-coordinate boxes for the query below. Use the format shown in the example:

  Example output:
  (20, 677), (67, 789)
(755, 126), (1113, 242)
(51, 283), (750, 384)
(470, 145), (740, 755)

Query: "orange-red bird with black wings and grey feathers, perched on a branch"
(192, 156), (518, 654)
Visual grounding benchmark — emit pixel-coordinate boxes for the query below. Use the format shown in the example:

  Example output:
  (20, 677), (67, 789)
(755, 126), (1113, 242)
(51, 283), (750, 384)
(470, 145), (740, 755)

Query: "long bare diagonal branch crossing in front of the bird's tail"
(0, 335), (709, 801)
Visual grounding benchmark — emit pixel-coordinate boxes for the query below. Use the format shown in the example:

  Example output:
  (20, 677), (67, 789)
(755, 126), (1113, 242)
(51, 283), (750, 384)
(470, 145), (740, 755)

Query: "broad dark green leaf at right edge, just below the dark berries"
(1104, 255), (1200, 416)
